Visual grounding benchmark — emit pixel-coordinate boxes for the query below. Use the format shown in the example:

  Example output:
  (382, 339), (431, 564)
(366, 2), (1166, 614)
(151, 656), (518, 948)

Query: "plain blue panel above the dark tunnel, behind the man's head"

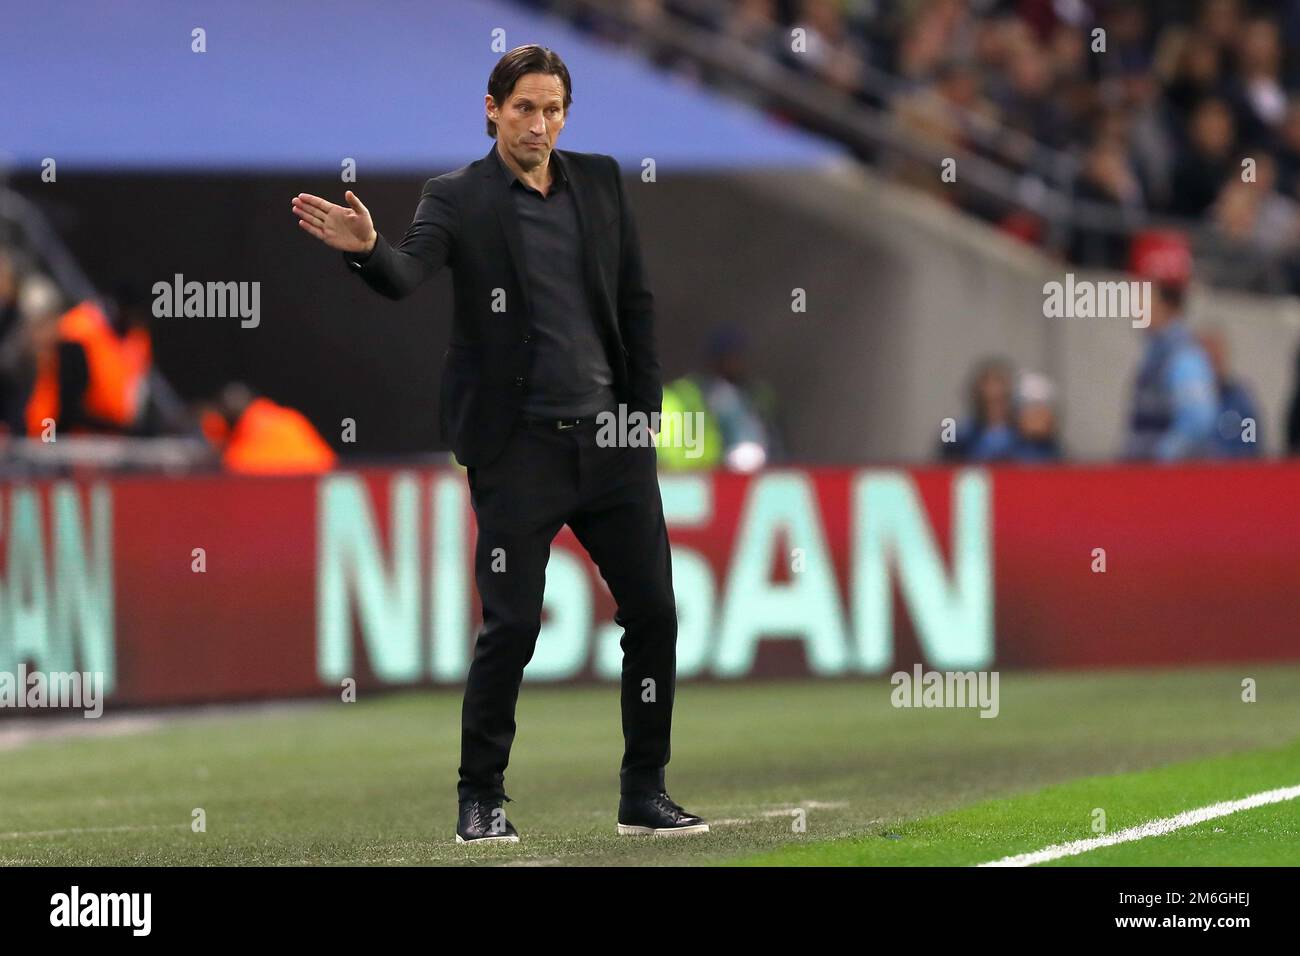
(0, 0), (842, 173)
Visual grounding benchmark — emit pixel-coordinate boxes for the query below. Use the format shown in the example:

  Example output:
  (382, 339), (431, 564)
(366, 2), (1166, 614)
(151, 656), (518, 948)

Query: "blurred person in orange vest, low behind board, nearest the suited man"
(199, 382), (338, 475)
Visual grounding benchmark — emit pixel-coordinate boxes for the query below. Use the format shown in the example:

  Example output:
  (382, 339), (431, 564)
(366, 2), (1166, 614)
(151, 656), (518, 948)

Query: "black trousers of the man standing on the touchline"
(456, 419), (677, 800)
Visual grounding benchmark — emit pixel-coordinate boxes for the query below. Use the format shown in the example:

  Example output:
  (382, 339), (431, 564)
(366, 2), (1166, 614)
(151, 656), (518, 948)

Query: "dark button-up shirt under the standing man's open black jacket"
(491, 150), (615, 418)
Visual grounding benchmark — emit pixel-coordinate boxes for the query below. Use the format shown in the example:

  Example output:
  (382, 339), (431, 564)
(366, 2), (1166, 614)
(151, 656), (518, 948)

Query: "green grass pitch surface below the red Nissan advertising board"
(0, 666), (1300, 866)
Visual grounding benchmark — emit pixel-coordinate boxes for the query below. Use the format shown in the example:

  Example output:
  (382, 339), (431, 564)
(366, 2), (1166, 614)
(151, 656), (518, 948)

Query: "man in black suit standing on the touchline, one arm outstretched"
(293, 46), (709, 843)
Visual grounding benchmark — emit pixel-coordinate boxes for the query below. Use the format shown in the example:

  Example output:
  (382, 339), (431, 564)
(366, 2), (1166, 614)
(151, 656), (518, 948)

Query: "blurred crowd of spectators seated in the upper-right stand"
(548, 0), (1300, 293)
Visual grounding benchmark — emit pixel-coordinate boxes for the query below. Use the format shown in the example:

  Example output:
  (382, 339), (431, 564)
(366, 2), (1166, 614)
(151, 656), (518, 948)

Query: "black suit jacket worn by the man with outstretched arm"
(345, 142), (663, 466)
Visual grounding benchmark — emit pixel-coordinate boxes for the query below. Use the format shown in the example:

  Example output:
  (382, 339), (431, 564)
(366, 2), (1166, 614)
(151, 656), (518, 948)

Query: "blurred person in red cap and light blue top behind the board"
(1126, 230), (1218, 462)
